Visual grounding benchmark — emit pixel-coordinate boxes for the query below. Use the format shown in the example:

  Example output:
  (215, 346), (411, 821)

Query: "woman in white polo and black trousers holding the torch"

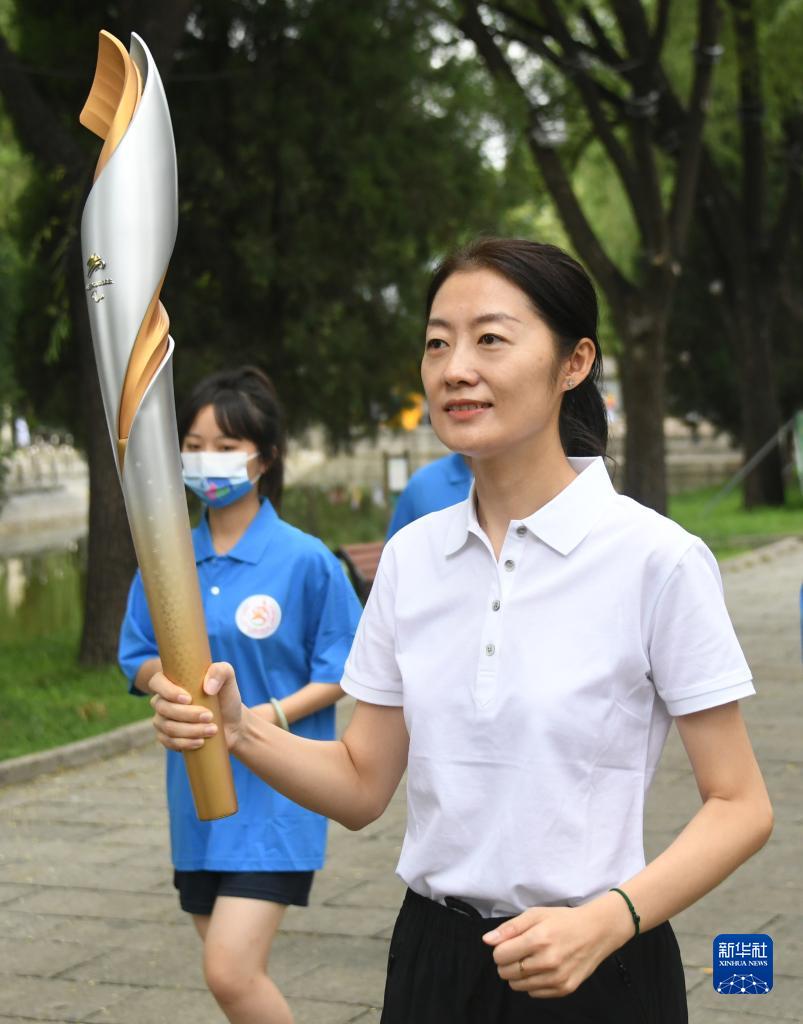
(145, 239), (772, 1024)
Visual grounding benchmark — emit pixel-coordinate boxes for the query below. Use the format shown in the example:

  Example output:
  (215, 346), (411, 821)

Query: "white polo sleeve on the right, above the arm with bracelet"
(647, 539), (755, 716)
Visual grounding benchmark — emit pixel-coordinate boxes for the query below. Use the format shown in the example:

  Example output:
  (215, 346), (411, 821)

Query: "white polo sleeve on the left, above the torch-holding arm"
(340, 544), (403, 708)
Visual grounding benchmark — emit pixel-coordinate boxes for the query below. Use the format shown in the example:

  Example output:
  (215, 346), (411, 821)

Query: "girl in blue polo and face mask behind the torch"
(119, 367), (362, 1024)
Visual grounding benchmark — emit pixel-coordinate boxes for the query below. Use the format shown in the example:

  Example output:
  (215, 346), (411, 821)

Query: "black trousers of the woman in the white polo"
(381, 890), (688, 1024)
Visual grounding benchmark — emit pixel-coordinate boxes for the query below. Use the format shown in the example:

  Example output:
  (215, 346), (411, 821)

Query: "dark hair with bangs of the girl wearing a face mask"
(178, 367), (287, 509)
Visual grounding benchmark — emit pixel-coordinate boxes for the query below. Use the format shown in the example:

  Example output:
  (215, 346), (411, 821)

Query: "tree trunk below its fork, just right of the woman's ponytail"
(616, 300), (668, 515)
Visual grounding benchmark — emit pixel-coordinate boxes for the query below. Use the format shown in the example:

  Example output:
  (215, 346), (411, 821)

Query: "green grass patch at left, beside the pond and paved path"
(0, 632), (151, 760)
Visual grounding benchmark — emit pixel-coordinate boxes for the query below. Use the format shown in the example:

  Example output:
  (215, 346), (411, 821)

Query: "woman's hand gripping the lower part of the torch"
(149, 662), (243, 751)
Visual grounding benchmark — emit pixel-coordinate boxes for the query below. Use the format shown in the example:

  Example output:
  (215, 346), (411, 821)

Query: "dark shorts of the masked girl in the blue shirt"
(173, 871), (315, 916)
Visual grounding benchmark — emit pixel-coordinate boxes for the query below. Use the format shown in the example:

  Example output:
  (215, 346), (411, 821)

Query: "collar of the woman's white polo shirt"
(446, 456), (616, 555)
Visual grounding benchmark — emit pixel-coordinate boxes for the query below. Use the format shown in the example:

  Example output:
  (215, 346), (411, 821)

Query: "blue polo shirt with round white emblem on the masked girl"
(119, 500), (362, 871)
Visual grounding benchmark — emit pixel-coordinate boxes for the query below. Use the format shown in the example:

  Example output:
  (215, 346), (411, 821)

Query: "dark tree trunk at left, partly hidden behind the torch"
(68, 233), (136, 665)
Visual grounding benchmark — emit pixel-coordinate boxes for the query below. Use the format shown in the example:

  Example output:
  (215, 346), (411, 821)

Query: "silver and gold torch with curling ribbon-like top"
(80, 32), (237, 820)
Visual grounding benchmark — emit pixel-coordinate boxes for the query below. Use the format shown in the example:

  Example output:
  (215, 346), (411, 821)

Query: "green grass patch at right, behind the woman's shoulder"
(669, 486), (803, 558)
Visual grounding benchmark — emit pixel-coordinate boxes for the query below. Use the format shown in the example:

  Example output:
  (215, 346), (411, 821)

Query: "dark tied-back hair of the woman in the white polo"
(426, 239), (607, 456)
